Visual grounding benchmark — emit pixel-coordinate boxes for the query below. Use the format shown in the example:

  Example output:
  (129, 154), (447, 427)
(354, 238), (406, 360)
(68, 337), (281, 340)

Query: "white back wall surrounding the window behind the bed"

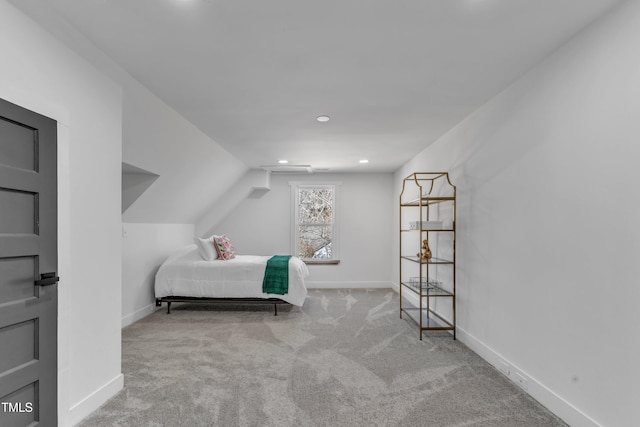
(208, 173), (395, 287)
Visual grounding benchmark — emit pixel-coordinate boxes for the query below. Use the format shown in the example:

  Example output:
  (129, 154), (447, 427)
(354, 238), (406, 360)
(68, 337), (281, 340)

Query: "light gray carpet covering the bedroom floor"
(80, 289), (565, 427)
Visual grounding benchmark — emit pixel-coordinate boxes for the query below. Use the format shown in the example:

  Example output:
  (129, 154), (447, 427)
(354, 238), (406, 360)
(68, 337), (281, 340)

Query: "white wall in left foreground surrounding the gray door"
(0, 0), (122, 426)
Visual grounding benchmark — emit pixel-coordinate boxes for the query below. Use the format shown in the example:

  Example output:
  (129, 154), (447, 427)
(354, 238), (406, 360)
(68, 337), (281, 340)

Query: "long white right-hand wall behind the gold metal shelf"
(393, 1), (640, 426)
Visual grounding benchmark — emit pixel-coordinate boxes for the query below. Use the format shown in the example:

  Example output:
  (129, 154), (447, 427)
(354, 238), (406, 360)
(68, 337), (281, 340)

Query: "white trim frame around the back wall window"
(289, 181), (342, 264)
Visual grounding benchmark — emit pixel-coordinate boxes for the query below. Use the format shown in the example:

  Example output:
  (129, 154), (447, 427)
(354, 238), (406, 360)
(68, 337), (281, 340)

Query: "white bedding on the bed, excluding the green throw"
(155, 245), (309, 306)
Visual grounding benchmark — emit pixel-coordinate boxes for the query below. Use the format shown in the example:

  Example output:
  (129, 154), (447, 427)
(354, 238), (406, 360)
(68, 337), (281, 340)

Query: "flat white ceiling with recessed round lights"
(10, 0), (620, 172)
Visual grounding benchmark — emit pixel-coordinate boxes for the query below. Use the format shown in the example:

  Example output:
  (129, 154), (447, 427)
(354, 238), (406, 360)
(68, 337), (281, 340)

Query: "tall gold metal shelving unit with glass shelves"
(400, 172), (456, 339)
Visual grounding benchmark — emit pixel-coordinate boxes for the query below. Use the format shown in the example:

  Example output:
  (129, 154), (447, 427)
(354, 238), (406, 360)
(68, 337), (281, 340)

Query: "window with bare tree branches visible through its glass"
(291, 183), (338, 263)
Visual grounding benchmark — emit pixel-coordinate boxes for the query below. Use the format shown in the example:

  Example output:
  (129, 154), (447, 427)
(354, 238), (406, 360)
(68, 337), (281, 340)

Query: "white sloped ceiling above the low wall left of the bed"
(122, 80), (247, 224)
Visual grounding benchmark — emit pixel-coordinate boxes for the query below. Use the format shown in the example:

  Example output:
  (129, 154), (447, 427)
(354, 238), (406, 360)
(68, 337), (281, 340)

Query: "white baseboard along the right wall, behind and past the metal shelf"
(391, 283), (601, 427)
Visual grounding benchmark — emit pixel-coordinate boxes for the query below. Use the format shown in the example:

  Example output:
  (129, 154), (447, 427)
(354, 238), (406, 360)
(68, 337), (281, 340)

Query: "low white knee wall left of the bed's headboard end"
(122, 223), (194, 327)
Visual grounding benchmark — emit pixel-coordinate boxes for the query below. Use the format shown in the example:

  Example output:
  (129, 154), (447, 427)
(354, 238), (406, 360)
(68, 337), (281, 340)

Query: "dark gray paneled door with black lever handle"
(0, 100), (58, 427)
